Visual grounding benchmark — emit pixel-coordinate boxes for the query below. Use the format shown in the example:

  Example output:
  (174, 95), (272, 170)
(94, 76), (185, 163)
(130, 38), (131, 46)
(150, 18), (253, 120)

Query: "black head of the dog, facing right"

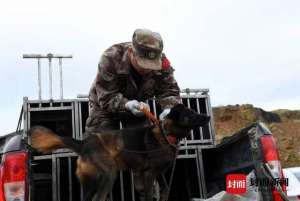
(164, 104), (210, 139)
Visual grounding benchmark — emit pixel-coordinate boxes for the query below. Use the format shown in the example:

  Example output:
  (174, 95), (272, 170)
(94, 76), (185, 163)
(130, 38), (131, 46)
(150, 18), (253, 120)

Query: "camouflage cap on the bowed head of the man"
(132, 29), (163, 70)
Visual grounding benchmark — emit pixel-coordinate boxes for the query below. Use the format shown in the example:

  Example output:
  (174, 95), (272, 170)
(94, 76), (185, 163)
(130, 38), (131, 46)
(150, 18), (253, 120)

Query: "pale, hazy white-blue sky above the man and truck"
(0, 0), (300, 135)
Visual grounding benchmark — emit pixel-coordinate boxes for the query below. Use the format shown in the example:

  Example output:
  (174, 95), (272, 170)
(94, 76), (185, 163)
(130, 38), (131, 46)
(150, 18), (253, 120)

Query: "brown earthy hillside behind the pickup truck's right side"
(213, 104), (300, 167)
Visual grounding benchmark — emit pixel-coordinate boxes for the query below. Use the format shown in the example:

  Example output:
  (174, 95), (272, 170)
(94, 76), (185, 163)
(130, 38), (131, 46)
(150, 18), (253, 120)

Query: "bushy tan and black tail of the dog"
(29, 126), (82, 154)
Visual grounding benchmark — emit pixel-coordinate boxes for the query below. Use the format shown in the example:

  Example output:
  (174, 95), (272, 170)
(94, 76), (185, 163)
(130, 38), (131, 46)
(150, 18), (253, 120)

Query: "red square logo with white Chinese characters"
(226, 174), (247, 194)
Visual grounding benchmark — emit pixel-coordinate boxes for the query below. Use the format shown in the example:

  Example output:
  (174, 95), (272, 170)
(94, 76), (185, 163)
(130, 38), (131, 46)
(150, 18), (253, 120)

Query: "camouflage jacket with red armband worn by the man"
(89, 42), (180, 118)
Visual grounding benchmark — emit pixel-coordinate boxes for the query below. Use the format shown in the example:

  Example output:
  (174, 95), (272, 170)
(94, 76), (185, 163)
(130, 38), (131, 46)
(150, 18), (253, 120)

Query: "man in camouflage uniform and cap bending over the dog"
(86, 29), (180, 133)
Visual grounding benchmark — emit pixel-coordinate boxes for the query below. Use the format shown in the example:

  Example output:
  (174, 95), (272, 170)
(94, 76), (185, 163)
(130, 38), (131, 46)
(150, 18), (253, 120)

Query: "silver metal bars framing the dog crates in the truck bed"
(23, 90), (215, 201)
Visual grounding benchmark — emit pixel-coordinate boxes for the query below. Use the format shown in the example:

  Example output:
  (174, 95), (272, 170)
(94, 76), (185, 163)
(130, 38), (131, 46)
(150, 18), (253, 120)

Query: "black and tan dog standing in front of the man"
(30, 104), (209, 201)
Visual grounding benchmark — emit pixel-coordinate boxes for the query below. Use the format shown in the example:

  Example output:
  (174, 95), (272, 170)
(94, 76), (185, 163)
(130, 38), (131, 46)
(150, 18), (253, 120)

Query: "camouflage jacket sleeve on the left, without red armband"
(94, 54), (128, 113)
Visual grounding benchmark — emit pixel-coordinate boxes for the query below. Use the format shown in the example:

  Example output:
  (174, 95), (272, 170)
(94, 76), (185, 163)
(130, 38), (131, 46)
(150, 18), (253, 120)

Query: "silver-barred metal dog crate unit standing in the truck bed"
(23, 90), (215, 201)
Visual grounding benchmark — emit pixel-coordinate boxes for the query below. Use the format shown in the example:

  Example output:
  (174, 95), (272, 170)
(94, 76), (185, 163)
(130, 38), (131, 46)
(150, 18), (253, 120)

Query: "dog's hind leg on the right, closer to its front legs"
(93, 170), (117, 201)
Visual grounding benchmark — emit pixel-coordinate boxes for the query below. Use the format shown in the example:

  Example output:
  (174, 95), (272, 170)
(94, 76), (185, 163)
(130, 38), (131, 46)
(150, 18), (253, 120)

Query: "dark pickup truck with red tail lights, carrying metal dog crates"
(0, 89), (285, 201)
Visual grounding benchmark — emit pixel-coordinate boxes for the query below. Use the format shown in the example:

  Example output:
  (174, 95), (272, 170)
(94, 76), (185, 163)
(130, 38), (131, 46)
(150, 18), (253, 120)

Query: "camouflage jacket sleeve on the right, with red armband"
(156, 54), (181, 109)
